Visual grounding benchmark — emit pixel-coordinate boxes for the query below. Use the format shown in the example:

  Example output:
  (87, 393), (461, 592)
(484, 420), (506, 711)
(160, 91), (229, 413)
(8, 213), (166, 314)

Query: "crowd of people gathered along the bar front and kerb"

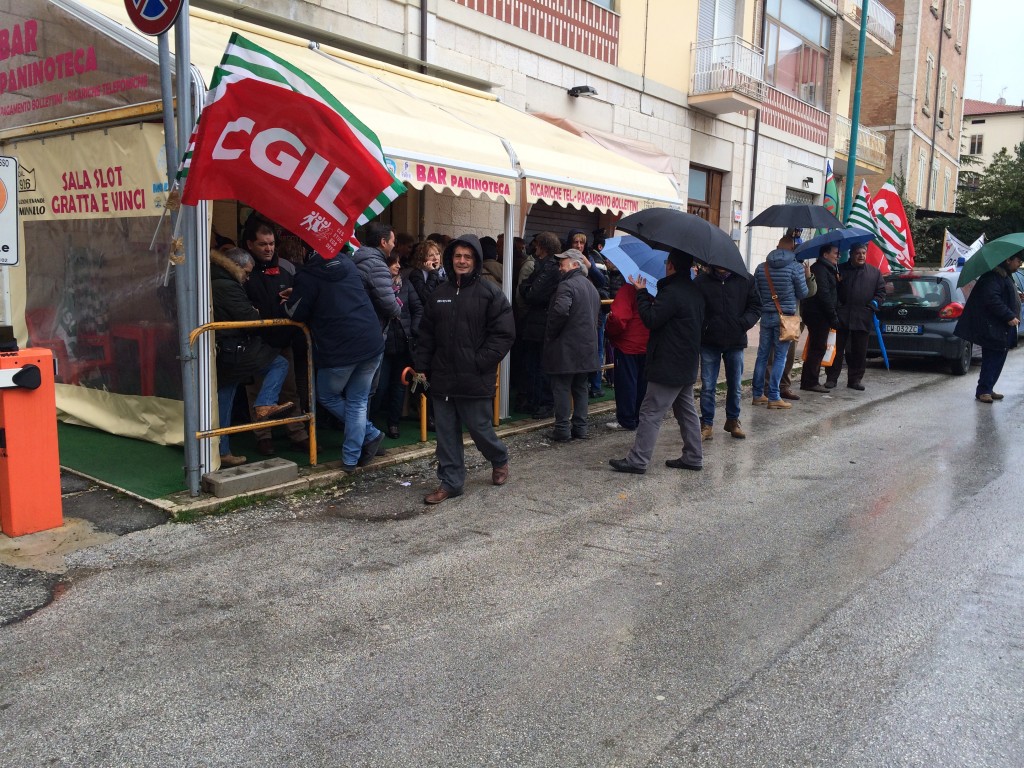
(205, 217), (1005, 504)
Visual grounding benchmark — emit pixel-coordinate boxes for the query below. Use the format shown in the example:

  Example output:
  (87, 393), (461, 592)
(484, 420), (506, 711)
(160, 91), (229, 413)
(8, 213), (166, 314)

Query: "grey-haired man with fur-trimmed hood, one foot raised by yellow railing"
(210, 248), (295, 467)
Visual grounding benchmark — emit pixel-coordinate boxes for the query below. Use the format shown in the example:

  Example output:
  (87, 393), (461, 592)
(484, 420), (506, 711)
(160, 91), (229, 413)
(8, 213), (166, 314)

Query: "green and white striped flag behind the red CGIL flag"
(177, 33), (406, 224)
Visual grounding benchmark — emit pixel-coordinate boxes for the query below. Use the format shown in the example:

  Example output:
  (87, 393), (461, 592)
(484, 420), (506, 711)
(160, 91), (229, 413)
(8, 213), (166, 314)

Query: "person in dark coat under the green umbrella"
(953, 252), (1024, 403)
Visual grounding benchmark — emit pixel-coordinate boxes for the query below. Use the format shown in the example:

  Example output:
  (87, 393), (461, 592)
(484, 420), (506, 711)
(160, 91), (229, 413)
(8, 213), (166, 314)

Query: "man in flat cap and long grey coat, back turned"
(544, 248), (601, 442)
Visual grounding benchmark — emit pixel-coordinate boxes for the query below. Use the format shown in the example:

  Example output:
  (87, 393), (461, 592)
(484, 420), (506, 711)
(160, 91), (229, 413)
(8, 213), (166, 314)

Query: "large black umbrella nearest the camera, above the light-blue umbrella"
(615, 208), (749, 274)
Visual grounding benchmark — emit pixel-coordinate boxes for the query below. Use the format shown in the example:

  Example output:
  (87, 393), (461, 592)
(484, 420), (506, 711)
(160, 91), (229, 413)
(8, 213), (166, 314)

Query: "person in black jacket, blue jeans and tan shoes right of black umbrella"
(694, 267), (761, 440)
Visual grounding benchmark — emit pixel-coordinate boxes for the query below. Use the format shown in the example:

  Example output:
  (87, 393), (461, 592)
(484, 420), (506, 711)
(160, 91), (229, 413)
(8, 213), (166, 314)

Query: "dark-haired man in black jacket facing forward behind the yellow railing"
(245, 220), (309, 456)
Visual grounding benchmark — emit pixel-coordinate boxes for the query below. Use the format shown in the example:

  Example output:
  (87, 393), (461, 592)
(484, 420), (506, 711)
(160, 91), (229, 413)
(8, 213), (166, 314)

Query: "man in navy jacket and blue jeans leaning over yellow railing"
(286, 254), (384, 472)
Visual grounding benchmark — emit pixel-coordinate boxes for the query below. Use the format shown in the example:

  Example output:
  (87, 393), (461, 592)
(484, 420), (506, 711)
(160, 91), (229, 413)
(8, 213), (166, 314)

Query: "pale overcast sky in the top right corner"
(962, 0), (1024, 104)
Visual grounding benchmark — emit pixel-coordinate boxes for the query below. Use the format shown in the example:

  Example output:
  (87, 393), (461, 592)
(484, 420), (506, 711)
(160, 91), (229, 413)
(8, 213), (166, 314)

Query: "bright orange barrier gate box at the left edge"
(0, 347), (63, 537)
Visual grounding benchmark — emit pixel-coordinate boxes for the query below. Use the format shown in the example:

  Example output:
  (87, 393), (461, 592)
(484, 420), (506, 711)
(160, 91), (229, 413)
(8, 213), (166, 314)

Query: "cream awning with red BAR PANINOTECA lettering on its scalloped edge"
(72, 0), (681, 214)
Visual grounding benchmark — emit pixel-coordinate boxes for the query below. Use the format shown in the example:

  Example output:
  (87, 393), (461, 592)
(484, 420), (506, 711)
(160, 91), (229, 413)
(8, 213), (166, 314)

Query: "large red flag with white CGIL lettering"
(181, 78), (393, 253)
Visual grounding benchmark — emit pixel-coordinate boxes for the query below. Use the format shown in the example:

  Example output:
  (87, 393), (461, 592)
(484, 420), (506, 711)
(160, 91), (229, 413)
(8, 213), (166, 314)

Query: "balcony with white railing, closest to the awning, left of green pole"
(689, 37), (765, 115)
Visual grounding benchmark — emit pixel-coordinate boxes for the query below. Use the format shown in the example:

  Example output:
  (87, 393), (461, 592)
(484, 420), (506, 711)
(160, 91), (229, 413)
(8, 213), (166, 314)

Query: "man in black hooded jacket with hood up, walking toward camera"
(415, 234), (515, 504)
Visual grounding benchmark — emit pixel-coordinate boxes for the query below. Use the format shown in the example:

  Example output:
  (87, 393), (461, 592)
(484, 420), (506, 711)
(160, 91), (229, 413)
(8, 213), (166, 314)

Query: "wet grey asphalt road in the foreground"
(0, 352), (1024, 768)
